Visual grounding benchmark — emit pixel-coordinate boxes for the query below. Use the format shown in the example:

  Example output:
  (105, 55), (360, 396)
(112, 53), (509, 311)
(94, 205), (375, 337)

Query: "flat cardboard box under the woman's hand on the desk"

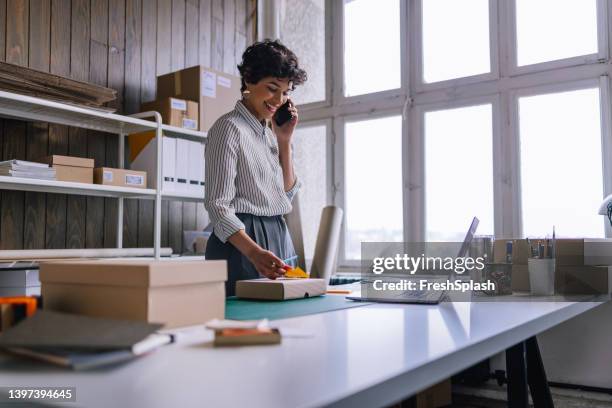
(236, 278), (327, 300)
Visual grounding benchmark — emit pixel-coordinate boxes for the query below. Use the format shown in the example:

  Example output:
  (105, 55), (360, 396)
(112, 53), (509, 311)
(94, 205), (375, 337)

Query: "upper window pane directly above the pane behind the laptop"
(422, 0), (491, 82)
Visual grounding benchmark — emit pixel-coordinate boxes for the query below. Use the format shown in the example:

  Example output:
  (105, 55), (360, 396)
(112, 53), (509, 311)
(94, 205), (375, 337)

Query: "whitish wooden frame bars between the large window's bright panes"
(272, 0), (612, 272)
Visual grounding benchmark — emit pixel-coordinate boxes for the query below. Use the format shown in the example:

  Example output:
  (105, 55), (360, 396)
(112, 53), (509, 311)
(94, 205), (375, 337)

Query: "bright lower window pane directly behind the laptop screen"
(425, 105), (494, 242)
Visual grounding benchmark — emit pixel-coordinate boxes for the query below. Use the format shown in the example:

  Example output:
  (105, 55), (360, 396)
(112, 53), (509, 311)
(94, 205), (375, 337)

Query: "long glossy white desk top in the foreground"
(0, 297), (607, 408)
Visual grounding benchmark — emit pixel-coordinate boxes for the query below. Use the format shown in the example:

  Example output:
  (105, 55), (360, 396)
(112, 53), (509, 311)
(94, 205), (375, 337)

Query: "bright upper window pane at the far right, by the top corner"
(516, 0), (597, 66)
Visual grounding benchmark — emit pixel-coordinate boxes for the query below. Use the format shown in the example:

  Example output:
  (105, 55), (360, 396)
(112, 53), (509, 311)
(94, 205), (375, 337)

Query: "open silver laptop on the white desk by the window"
(346, 217), (480, 304)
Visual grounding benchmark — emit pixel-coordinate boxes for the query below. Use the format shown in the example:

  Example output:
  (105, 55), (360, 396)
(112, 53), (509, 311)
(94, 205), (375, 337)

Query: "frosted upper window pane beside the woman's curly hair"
(280, 0), (325, 103)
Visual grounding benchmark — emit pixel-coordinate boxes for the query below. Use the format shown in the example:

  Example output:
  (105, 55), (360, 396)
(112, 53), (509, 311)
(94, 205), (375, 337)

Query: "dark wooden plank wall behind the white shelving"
(0, 0), (256, 252)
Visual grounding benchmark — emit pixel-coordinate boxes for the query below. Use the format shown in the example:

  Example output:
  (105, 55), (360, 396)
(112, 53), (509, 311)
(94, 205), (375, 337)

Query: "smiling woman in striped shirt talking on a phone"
(205, 40), (306, 296)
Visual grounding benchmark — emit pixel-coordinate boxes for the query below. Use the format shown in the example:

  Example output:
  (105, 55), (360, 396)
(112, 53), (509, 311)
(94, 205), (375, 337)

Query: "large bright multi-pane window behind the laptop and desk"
(282, 0), (612, 270)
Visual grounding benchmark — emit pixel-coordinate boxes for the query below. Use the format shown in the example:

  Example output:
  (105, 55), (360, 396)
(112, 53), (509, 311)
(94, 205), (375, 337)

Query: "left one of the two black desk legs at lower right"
(506, 342), (529, 408)
